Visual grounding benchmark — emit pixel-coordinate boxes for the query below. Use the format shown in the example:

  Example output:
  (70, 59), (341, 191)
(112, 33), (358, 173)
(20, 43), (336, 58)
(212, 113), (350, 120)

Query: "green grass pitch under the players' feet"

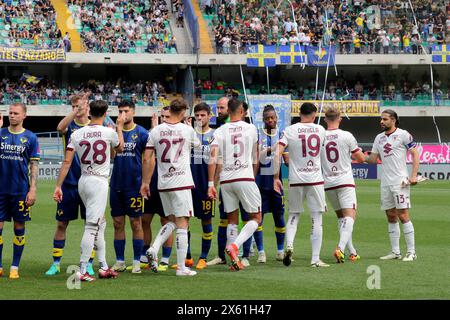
(0, 181), (450, 301)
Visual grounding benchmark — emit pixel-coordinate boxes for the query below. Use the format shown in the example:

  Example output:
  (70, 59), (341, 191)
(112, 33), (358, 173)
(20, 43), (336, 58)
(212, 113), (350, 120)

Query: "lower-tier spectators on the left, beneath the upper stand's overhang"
(0, 76), (174, 106)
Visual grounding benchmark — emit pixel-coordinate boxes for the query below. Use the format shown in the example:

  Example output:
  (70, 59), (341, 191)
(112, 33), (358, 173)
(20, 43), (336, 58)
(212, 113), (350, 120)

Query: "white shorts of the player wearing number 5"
(220, 181), (261, 213)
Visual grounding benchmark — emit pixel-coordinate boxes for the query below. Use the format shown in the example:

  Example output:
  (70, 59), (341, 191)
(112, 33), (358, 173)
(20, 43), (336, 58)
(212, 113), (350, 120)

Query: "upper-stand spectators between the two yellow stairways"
(68, 0), (176, 53)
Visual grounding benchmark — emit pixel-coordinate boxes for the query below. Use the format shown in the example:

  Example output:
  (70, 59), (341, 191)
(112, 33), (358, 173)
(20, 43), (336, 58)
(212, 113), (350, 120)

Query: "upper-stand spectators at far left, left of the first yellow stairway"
(0, 0), (71, 51)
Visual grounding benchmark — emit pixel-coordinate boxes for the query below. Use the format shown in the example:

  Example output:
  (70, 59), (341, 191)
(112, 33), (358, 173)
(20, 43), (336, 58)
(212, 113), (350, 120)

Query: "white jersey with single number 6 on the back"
(322, 129), (360, 190)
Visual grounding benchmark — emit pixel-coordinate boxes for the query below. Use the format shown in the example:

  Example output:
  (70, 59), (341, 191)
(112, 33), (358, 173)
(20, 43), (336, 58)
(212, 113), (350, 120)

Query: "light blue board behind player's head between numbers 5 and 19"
(247, 95), (291, 131)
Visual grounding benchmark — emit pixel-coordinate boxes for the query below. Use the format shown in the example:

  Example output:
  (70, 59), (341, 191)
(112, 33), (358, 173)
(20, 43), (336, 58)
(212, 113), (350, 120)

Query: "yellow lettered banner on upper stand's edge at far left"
(0, 47), (66, 62)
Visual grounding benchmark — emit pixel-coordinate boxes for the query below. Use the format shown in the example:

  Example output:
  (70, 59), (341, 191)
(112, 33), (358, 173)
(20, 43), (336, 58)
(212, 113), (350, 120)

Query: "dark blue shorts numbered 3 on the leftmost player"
(0, 191), (31, 222)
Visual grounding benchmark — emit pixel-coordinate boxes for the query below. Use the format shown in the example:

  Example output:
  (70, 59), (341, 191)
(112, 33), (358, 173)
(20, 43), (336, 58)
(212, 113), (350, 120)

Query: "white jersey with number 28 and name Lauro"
(67, 125), (119, 178)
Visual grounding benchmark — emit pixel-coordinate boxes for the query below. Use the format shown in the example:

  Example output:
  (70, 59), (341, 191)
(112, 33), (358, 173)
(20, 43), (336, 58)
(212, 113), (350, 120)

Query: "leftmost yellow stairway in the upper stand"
(50, 0), (85, 52)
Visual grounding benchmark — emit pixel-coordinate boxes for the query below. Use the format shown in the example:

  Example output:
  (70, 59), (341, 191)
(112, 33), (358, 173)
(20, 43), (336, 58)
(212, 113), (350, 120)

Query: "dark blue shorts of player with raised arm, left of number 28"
(56, 183), (86, 221)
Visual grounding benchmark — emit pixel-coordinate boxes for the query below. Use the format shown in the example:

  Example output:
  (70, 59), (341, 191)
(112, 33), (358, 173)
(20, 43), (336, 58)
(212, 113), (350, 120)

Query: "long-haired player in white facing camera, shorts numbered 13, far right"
(366, 109), (419, 261)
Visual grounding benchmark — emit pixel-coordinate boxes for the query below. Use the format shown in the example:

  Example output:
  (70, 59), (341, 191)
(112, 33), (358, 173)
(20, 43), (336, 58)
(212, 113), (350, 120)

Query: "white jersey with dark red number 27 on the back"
(146, 122), (200, 192)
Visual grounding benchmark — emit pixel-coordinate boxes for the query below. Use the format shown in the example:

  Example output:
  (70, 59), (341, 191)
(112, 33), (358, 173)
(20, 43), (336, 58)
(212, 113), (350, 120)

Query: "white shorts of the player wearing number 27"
(159, 189), (194, 218)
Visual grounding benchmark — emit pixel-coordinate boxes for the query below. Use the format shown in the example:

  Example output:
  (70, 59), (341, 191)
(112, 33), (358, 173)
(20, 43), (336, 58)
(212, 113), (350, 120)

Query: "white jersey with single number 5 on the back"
(211, 121), (258, 183)
